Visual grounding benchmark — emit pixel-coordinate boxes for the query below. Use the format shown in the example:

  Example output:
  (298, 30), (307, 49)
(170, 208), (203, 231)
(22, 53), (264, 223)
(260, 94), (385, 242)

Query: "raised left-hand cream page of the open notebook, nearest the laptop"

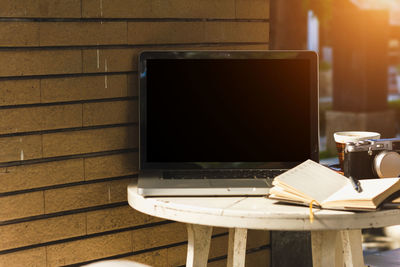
(274, 160), (349, 203)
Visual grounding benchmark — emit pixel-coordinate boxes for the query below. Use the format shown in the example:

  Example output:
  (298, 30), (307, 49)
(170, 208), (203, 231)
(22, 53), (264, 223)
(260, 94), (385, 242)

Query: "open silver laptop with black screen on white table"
(138, 51), (319, 196)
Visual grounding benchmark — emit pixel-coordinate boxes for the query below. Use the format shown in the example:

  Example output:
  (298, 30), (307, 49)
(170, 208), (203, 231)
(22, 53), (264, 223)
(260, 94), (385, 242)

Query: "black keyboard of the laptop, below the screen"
(163, 169), (286, 179)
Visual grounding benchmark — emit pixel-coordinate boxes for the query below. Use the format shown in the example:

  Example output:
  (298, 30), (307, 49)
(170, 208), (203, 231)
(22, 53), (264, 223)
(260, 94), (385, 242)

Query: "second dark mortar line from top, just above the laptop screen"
(0, 42), (269, 52)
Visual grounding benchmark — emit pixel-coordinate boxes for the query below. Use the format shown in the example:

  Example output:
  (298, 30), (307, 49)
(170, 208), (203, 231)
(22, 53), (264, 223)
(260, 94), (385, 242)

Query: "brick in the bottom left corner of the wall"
(0, 247), (46, 267)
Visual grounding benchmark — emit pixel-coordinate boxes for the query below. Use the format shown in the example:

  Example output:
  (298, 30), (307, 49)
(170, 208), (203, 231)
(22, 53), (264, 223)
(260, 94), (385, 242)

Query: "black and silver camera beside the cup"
(343, 138), (400, 179)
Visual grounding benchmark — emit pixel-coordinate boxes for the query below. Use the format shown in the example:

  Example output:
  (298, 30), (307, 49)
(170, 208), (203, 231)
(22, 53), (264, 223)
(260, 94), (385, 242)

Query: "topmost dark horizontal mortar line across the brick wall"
(0, 17), (270, 23)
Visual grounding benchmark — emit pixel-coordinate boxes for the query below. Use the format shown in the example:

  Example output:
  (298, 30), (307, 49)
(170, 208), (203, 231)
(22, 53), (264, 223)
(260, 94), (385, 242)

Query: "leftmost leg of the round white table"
(186, 224), (212, 267)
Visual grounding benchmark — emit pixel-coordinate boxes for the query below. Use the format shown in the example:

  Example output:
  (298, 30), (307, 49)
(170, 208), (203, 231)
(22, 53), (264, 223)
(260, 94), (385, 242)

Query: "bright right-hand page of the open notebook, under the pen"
(322, 178), (400, 206)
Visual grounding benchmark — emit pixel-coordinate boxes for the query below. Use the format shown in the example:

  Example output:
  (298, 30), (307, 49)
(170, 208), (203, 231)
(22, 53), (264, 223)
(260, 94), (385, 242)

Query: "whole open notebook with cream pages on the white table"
(268, 160), (400, 213)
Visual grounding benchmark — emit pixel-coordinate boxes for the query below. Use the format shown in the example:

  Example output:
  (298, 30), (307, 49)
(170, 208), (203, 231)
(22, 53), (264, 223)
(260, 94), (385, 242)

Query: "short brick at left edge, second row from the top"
(0, 21), (39, 46)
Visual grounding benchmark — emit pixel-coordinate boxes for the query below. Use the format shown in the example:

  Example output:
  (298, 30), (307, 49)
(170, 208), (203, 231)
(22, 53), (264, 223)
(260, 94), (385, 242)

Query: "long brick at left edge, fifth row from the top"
(0, 104), (82, 134)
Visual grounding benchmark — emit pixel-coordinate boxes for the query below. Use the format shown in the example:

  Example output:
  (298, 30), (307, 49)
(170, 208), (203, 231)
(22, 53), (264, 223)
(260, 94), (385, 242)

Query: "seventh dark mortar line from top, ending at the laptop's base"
(0, 173), (138, 200)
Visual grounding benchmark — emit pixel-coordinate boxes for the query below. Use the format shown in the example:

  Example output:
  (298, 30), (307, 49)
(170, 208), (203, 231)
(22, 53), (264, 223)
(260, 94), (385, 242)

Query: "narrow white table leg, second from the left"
(227, 228), (247, 267)
